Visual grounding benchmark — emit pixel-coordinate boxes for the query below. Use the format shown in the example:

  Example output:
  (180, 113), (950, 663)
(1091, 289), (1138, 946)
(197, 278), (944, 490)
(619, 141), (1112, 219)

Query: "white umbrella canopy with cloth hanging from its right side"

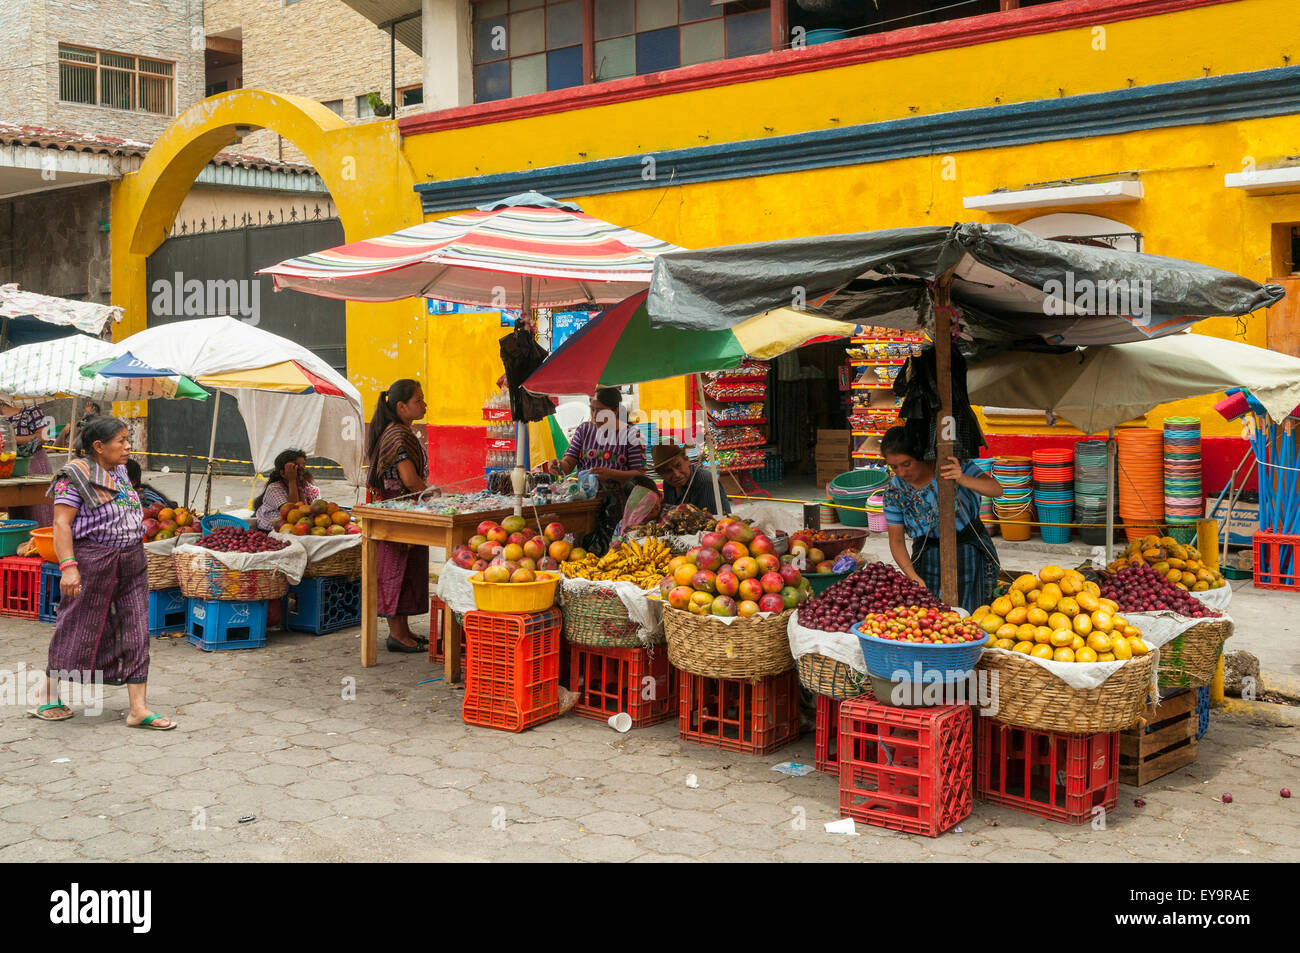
(82, 317), (365, 486)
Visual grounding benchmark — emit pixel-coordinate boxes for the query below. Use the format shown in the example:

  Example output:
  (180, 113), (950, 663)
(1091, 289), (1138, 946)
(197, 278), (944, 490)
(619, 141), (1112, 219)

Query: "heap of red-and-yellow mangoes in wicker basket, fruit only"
(659, 517), (813, 619)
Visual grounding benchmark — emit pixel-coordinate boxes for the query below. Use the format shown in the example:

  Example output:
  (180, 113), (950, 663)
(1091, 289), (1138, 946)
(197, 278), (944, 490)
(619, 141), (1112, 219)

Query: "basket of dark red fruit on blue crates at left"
(172, 527), (297, 602)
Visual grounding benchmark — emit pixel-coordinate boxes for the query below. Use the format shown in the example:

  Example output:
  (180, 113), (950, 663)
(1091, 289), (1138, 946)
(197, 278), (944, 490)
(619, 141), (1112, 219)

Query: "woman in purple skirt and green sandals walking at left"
(27, 417), (176, 731)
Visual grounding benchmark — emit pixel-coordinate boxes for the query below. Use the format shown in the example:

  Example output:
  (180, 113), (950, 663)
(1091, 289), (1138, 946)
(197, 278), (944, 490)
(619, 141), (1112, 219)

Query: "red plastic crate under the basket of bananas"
(568, 645), (677, 728)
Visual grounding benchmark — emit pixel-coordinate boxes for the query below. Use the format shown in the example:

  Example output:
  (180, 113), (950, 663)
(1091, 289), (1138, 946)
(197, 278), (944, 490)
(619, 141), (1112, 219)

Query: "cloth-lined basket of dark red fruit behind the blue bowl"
(788, 555), (940, 701)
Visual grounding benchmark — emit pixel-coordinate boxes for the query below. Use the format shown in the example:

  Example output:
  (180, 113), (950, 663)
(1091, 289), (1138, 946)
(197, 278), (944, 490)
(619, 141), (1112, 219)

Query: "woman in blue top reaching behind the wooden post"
(880, 426), (1002, 612)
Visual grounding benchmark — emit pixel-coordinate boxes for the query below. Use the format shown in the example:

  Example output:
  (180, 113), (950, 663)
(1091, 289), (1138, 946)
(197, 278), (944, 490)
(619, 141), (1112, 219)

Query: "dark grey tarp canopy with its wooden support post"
(646, 222), (1284, 602)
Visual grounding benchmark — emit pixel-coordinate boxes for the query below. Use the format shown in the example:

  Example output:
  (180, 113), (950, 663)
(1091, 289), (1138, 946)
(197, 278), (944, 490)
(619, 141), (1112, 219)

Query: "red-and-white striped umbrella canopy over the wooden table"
(259, 192), (679, 309)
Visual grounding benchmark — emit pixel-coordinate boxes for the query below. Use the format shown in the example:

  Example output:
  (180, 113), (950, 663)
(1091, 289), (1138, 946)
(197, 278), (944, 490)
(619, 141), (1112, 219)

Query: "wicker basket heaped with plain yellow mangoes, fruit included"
(971, 566), (1160, 735)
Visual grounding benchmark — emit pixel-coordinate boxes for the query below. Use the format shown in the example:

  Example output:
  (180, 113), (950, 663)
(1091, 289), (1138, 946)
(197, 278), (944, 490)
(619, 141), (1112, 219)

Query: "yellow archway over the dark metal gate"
(111, 90), (426, 416)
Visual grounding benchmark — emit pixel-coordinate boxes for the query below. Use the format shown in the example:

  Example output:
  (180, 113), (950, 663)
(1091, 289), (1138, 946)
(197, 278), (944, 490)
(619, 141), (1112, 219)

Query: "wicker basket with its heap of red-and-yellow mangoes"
(660, 523), (813, 679)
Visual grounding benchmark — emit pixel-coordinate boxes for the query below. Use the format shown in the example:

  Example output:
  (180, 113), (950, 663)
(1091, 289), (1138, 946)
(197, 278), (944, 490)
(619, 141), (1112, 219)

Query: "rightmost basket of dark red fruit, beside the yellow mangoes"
(1101, 564), (1232, 688)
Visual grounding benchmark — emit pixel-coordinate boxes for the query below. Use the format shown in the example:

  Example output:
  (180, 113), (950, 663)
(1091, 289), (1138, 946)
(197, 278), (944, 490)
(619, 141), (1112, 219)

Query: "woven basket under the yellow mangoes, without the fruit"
(979, 651), (1156, 735)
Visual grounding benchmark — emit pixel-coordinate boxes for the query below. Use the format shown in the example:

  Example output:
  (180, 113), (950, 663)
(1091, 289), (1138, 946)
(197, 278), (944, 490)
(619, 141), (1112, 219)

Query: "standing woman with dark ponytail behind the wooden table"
(367, 378), (429, 653)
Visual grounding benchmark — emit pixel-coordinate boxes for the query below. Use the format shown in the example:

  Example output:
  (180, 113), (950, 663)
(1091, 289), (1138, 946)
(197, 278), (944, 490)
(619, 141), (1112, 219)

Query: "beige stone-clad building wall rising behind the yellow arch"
(203, 0), (424, 163)
